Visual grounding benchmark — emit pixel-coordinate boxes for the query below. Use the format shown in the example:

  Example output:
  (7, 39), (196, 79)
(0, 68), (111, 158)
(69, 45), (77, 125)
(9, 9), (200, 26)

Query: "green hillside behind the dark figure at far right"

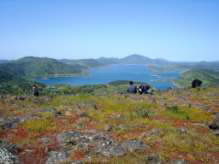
(175, 69), (219, 87)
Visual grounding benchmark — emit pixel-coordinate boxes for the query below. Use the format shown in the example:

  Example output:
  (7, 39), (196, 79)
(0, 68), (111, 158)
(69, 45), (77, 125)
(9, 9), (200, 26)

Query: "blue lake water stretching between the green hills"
(37, 64), (179, 89)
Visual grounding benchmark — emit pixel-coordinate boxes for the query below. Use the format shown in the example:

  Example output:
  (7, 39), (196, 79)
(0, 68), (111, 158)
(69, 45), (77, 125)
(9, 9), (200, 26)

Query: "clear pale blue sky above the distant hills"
(0, 0), (219, 61)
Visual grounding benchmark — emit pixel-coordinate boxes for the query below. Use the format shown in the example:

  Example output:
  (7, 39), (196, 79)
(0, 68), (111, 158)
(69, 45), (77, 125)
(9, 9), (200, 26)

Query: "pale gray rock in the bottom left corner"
(0, 148), (19, 164)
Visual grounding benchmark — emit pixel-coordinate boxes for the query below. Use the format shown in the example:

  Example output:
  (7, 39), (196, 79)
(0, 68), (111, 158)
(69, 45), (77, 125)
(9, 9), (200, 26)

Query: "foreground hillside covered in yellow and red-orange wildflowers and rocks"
(0, 85), (219, 164)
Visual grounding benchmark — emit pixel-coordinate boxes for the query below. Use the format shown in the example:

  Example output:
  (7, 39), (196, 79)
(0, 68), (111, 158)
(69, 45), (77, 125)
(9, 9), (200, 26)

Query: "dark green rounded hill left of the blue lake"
(0, 57), (86, 78)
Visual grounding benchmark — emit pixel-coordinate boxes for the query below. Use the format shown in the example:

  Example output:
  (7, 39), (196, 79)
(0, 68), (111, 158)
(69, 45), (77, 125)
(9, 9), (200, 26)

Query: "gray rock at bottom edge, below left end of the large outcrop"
(46, 151), (67, 164)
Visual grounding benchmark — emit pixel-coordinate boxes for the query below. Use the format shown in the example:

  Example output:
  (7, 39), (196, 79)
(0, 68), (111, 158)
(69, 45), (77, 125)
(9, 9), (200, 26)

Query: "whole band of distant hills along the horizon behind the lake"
(0, 54), (219, 81)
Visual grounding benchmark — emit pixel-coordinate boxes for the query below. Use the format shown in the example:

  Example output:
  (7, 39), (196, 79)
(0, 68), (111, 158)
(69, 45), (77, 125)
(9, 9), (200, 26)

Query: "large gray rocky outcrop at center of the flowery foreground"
(57, 131), (147, 157)
